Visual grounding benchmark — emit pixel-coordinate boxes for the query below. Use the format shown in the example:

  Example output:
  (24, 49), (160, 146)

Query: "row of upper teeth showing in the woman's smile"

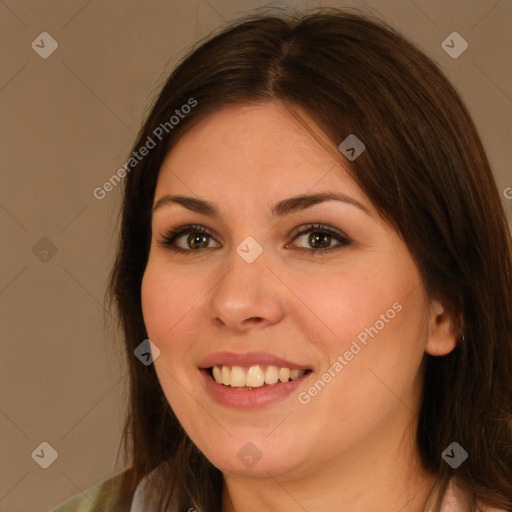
(212, 365), (306, 388)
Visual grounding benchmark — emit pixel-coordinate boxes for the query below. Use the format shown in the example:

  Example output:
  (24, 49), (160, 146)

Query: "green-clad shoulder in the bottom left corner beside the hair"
(51, 470), (127, 512)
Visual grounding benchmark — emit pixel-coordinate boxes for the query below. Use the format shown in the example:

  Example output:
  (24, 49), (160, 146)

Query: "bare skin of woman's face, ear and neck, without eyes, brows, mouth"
(141, 102), (459, 512)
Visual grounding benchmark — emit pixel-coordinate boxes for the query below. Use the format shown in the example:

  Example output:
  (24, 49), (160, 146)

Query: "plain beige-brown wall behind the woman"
(0, 0), (512, 512)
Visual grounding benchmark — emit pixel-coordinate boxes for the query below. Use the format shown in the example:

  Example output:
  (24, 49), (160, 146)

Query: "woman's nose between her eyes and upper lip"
(207, 243), (284, 333)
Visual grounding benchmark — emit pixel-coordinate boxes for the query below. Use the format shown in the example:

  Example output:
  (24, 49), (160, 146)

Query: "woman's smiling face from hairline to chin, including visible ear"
(141, 102), (454, 477)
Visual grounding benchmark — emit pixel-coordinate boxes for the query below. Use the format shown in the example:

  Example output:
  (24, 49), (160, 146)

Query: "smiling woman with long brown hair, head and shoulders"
(51, 9), (512, 512)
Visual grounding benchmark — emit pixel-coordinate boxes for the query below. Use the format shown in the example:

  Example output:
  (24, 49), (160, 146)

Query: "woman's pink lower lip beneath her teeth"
(200, 369), (313, 409)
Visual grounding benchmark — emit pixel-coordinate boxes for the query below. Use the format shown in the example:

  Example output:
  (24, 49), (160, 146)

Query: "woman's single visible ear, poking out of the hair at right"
(425, 300), (462, 356)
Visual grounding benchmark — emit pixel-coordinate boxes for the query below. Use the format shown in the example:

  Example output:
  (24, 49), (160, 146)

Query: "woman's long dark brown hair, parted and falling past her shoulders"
(109, 9), (512, 512)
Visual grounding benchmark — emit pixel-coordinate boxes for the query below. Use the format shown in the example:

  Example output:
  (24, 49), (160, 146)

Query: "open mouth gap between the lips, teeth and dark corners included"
(204, 364), (312, 391)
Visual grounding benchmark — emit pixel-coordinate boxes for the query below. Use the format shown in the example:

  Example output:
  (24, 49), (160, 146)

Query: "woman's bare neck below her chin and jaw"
(222, 416), (435, 512)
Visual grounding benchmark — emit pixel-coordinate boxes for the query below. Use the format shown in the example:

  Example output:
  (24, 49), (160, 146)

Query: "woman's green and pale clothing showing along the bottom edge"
(47, 473), (512, 512)
